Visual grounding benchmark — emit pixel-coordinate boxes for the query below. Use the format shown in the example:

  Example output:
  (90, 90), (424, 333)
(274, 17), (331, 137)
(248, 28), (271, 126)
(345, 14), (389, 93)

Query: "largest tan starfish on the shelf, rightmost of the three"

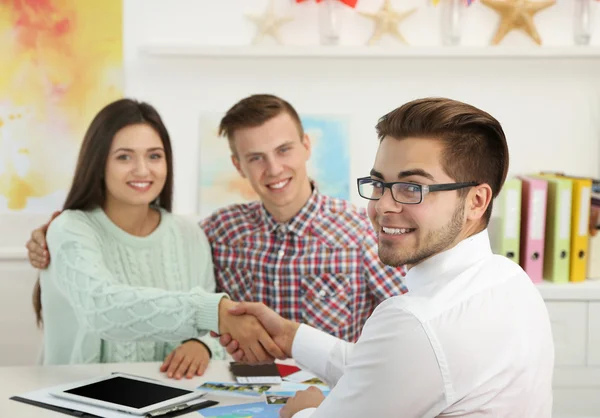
(481, 0), (556, 45)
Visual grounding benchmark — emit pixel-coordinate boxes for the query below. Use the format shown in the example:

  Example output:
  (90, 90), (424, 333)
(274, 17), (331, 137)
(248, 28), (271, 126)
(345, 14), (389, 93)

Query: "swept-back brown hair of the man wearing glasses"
(375, 98), (508, 226)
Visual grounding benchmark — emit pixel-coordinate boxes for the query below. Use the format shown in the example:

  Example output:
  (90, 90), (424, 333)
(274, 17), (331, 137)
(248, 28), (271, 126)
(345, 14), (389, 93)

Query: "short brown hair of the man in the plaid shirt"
(219, 94), (304, 150)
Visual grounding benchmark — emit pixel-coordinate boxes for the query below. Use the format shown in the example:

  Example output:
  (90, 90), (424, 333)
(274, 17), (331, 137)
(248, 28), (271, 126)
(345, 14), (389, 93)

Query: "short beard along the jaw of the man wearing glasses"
(379, 201), (465, 267)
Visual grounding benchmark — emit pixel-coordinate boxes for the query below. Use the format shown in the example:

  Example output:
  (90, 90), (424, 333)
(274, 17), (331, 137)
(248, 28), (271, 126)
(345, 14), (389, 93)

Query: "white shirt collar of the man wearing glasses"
(405, 229), (493, 293)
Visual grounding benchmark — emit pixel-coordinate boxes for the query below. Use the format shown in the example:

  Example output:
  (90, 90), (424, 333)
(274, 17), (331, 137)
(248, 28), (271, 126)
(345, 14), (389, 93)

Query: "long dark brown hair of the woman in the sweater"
(33, 99), (173, 326)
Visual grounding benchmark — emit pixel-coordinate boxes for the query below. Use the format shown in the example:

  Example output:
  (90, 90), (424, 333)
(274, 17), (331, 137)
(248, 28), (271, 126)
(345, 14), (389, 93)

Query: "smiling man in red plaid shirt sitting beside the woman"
(201, 95), (406, 342)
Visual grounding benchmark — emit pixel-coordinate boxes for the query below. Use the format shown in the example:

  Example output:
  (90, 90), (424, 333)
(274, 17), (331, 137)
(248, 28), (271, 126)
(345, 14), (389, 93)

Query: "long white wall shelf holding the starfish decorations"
(141, 43), (600, 59)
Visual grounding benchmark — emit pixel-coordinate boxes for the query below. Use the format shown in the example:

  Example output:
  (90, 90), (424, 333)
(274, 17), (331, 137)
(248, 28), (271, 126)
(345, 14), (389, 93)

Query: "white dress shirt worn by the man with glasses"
(292, 230), (554, 418)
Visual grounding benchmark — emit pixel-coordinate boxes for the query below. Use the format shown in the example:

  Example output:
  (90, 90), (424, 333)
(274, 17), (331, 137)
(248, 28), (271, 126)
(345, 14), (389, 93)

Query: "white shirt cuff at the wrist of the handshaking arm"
(292, 324), (339, 380)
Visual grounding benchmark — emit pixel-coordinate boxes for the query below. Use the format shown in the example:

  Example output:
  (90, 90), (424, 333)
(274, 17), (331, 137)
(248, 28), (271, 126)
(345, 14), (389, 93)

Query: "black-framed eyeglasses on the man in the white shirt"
(357, 177), (479, 205)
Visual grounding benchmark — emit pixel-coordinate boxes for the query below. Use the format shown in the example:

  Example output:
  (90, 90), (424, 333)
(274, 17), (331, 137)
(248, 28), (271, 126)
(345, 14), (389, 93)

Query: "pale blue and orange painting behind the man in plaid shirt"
(198, 113), (350, 217)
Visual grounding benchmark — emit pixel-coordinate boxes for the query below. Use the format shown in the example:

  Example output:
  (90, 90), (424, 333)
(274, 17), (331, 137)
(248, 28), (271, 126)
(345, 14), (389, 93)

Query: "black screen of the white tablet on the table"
(64, 377), (192, 409)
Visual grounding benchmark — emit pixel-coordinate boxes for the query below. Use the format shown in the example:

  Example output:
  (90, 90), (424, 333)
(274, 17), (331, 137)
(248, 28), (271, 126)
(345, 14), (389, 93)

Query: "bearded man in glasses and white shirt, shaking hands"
(216, 99), (554, 418)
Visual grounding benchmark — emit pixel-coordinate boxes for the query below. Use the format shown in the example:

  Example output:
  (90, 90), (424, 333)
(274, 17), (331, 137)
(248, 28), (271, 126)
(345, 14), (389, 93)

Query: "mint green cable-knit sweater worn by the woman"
(40, 208), (224, 364)
